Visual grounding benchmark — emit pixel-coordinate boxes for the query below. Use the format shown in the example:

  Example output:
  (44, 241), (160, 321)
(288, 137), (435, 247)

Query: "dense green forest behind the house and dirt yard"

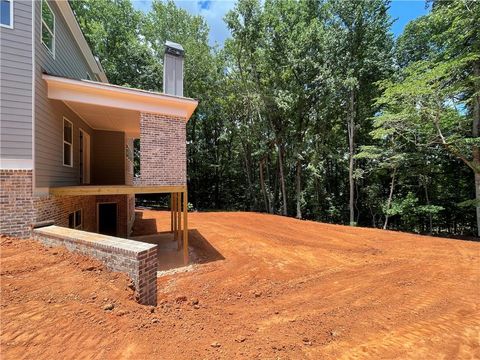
(70, 0), (480, 238)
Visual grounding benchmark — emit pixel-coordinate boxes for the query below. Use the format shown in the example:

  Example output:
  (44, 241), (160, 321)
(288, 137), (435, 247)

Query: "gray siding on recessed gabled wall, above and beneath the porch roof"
(35, 1), (95, 187)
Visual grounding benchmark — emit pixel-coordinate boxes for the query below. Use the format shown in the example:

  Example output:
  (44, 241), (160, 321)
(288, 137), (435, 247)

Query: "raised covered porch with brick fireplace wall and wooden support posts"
(43, 74), (198, 264)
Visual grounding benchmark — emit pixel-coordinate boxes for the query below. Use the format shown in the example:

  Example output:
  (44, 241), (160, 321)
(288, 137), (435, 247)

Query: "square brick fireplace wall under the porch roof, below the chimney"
(140, 113), (187, 185)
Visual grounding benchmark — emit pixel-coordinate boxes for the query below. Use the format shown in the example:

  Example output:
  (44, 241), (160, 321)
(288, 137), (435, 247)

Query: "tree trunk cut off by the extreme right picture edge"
(472, 61), (480, 237)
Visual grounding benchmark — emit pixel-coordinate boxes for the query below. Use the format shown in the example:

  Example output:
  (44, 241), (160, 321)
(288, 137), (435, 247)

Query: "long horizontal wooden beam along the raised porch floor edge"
(49, 185), (187, 196)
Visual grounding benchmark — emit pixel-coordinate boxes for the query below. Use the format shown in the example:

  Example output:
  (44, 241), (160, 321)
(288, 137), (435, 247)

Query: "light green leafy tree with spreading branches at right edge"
(376, 1), (480, 236)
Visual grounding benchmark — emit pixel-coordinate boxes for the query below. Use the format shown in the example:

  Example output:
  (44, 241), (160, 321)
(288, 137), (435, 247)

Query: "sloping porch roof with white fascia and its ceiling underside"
(43, 74), (198, 137)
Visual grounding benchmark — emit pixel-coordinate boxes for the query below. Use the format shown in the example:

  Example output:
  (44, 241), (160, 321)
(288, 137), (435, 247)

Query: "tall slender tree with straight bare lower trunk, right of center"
(330, 0), (393, 225)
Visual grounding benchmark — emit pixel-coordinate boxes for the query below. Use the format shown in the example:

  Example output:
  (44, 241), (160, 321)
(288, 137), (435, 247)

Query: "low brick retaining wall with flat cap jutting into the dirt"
(33, 226), (157, 305)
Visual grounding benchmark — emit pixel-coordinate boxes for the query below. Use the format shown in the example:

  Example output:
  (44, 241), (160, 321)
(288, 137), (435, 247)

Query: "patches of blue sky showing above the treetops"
(133, 0), (428, 46)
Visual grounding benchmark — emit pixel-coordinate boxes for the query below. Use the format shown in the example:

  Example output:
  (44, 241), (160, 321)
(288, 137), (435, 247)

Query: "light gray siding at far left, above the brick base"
(0, 1), (33, 159)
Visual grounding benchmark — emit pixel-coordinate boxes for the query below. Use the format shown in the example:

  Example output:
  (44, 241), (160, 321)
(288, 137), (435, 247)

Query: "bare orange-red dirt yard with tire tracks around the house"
(1, 211), (480, 359)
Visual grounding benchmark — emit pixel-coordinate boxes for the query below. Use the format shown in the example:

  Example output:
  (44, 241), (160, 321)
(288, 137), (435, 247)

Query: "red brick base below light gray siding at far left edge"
(0, 170), (35, 237)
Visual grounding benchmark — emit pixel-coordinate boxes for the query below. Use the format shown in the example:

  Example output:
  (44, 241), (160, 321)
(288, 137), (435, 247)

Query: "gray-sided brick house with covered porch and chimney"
(0, 0), (197, 264)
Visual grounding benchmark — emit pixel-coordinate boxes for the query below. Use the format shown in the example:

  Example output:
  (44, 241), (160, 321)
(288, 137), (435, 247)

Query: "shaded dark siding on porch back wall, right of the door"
(91, 130), (125, 185)
